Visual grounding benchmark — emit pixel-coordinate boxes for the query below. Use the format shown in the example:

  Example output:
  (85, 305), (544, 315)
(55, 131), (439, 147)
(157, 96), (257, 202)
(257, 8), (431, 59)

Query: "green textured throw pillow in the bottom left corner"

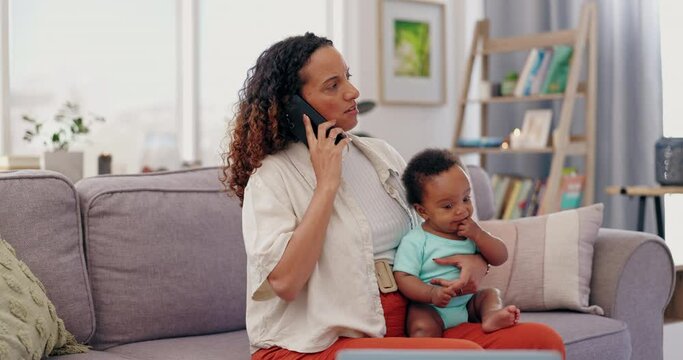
(0, 239), (88, 359)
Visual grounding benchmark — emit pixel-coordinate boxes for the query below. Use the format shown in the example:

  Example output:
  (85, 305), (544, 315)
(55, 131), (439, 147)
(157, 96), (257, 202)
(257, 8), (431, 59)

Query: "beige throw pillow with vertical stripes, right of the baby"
(480, 204), (604, 315)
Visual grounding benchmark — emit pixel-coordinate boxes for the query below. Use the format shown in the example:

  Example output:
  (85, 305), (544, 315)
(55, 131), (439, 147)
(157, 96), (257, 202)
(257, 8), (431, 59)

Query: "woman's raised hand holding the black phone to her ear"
(303, 115), (351, 192)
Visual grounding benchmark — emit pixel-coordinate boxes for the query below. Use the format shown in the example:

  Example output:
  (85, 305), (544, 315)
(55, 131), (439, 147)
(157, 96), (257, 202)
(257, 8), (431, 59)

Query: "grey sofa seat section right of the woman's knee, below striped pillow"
(522, 311), (631, 360)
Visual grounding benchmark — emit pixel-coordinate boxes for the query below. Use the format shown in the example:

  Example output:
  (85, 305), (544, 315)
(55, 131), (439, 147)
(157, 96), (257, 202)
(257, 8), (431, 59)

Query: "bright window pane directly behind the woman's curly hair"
(199, 0), (331, 165)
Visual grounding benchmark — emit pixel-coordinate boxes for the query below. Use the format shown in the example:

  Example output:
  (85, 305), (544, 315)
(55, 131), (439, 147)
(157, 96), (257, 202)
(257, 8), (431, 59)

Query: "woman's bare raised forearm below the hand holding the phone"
(268, 186), (337, 301)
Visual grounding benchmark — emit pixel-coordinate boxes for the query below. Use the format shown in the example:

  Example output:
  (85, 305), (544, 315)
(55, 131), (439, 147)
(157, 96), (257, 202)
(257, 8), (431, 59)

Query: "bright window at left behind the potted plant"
(9, 0), (179, 176)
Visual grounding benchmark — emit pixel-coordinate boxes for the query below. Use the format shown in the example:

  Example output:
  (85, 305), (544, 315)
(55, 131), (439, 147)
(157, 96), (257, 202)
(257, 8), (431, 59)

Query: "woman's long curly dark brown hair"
(221, 32), (333, 205)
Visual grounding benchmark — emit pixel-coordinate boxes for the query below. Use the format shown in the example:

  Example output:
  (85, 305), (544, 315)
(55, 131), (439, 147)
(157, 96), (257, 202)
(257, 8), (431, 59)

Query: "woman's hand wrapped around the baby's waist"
(430, 254), (488, 295)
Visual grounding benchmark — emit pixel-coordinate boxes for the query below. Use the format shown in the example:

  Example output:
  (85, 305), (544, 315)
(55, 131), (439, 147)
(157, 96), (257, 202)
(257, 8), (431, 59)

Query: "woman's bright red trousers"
(251, 292), (565, 360)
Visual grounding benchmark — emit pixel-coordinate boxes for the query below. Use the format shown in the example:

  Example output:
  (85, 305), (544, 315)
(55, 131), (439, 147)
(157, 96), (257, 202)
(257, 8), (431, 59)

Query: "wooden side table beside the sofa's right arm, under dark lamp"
(605, 185), (683, 239)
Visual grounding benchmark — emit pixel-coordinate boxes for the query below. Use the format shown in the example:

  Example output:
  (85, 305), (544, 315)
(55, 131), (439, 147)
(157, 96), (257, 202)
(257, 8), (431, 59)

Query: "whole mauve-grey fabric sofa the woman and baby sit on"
(0, 167), (673, 360)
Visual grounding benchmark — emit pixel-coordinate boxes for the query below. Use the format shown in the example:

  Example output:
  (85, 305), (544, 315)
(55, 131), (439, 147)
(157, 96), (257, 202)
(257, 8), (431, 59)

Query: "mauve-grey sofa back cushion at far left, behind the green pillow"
(0, 170), (95, 342)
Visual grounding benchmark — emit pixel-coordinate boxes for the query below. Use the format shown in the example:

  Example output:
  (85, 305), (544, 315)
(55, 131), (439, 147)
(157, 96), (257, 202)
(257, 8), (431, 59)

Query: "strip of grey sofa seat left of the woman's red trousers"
(108, 330), (251, 360)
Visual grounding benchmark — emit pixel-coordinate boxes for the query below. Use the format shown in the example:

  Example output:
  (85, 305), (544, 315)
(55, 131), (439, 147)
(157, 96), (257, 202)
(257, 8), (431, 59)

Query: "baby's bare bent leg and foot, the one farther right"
(467, 288), (520, 333)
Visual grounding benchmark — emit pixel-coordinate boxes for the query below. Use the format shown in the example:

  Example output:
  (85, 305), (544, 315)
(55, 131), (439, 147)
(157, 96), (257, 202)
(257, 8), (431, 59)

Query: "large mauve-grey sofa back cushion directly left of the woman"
(76, 168), (246, 349)
